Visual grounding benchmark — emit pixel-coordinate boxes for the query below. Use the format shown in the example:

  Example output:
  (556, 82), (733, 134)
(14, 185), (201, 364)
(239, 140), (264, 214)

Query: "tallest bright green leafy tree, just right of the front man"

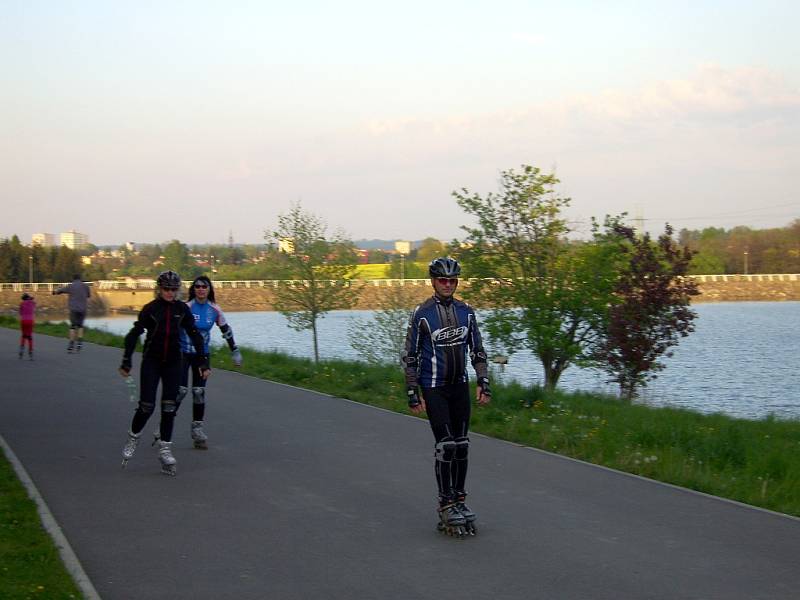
(453, 165), (618, 390)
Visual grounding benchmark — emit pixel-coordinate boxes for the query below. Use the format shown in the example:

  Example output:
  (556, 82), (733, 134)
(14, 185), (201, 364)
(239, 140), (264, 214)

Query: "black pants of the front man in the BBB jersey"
(422, 383), (471, 505)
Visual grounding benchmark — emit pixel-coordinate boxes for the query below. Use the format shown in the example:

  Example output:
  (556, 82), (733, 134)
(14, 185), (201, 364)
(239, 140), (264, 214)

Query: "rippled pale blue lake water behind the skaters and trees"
(86, 302), (800, 418)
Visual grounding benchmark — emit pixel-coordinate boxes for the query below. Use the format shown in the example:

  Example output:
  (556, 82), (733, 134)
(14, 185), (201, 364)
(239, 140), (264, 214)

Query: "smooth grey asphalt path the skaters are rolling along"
(0, 329), (800, 600)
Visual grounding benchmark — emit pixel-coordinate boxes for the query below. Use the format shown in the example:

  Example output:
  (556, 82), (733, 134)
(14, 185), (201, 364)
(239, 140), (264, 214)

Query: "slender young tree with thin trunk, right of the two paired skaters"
(265, 203), (356, 361)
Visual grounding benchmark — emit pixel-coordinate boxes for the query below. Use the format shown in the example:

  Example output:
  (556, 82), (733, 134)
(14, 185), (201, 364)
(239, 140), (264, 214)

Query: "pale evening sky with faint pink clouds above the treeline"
(0, 0), (800, 245)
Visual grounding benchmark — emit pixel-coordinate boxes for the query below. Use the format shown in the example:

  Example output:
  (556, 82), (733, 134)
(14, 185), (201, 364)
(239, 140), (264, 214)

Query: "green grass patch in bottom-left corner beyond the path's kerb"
(0, 452), (83, 600)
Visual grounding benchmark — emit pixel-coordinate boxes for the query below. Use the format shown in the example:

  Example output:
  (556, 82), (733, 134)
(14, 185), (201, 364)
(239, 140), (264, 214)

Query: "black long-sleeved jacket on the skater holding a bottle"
(124, 298), (208, 369)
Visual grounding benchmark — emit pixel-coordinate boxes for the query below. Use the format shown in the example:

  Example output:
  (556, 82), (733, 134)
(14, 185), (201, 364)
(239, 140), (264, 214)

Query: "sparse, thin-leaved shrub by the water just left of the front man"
(347, 286), (415, 364)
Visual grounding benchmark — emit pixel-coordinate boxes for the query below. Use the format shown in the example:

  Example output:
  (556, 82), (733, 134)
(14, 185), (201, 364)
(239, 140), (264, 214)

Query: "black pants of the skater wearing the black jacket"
(131, 357), (181, 442)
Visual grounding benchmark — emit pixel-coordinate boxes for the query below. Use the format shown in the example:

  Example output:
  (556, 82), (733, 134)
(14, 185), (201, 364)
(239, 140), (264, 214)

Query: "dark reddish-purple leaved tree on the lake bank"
(592, 223), (699, 400)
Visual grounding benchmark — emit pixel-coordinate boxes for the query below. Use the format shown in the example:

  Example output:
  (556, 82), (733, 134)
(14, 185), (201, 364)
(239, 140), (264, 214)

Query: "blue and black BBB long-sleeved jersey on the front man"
(403, 295), (489, 388)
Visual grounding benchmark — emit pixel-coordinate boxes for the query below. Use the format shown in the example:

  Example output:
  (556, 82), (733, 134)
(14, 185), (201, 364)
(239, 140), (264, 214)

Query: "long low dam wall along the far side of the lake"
(0, 275), (800, 316)
